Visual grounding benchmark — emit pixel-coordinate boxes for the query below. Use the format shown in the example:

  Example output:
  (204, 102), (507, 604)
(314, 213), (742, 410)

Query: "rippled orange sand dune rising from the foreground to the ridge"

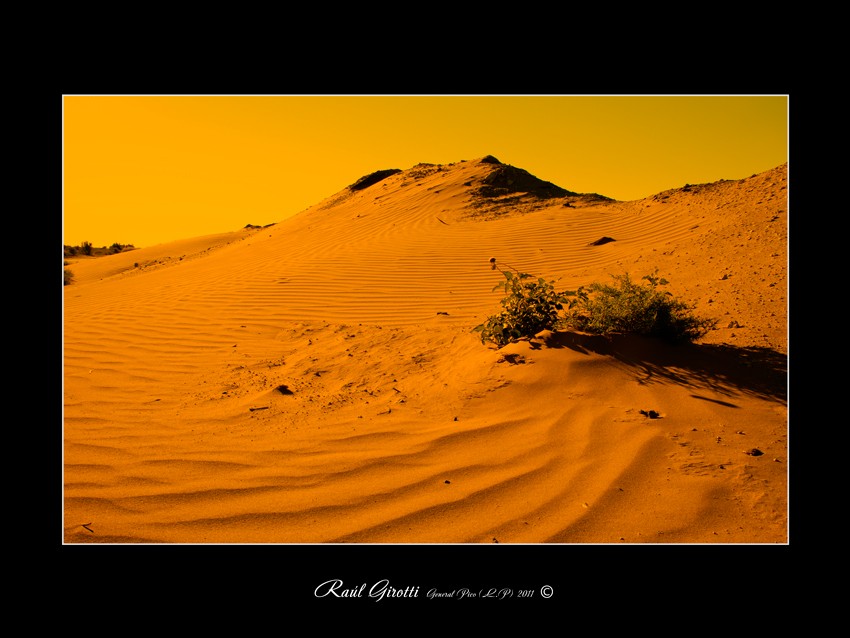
(64, 156), (788, 544)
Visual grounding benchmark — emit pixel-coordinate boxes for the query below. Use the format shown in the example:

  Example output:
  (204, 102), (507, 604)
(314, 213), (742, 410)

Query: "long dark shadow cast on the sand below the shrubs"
(532, 331), (788, 407)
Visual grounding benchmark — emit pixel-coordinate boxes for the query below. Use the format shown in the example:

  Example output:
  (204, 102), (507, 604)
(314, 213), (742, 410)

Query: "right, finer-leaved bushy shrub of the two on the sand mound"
(563, 271), (717, 342)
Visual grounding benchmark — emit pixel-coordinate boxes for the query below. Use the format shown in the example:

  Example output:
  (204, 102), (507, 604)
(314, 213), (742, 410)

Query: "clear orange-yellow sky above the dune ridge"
(62, 95), (788, 247)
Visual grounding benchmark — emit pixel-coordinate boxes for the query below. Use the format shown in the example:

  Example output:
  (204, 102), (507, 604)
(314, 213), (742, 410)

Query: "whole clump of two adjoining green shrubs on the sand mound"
(474, 259), (717, 348)
